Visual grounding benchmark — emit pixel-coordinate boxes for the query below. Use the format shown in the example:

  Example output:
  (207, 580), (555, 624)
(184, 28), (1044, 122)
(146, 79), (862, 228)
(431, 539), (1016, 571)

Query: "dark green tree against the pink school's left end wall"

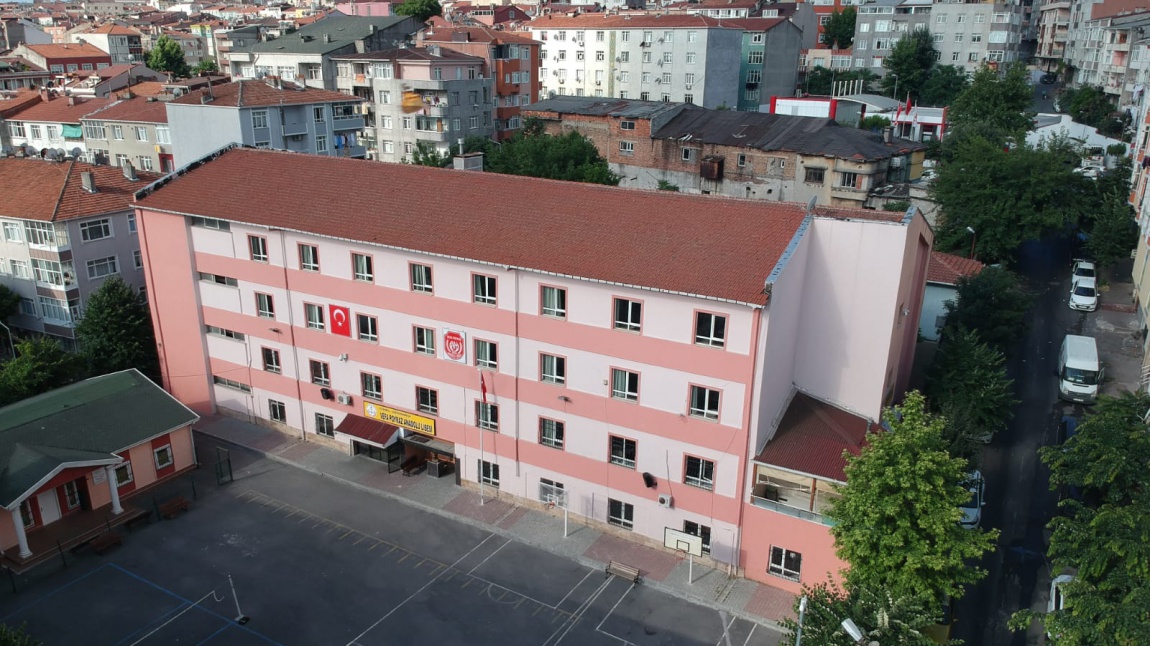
(76, 276), (160, 378)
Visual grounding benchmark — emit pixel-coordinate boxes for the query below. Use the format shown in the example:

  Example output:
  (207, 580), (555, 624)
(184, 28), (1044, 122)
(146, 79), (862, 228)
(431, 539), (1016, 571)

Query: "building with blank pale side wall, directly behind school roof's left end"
(164, 78), (367, 168)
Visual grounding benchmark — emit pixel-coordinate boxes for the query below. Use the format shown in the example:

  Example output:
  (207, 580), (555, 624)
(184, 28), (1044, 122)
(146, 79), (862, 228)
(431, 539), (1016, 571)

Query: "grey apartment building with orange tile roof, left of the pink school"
(0, 157), (160, 346)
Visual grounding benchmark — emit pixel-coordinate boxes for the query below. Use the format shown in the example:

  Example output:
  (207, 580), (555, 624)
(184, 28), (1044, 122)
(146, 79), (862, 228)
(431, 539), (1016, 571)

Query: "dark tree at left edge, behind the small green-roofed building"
(0, 337), (84, 406)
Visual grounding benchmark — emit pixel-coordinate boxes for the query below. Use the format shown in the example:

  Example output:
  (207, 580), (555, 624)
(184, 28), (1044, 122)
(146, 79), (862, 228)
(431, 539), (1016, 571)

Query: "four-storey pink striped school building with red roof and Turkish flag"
(137, 148), (932, 590)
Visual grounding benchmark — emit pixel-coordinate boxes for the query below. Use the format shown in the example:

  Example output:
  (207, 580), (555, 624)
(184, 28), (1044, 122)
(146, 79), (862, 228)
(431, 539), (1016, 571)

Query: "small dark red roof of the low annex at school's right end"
(754, 393), (871, 483)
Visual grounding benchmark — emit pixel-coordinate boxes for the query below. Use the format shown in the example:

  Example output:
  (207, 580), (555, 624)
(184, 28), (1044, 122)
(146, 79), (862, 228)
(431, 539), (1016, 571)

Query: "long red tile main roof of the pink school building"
(139, 148), (805, 305)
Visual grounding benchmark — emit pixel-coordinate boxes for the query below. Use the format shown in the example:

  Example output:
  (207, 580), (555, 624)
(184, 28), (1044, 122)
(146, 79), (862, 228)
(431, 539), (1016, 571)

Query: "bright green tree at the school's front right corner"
(827, 391), (998, 603)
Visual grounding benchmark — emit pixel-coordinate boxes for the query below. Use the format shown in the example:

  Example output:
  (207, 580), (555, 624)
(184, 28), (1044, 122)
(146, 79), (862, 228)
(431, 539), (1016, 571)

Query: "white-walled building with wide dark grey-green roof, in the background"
(221, 14), (423, 90)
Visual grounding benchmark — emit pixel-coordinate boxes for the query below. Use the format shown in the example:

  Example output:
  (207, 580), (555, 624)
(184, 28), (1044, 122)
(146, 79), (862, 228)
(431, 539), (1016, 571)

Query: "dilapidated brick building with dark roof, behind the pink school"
(528, 97), (926, 208)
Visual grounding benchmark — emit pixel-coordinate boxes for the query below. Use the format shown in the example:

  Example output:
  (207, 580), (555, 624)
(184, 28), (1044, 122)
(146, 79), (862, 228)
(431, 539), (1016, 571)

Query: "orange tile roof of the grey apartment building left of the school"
(0, 159), (160, 222)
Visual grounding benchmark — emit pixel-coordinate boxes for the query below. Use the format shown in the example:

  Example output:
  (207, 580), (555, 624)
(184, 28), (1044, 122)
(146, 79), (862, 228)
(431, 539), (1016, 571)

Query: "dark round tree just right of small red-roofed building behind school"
(943, 267), (1033, 352)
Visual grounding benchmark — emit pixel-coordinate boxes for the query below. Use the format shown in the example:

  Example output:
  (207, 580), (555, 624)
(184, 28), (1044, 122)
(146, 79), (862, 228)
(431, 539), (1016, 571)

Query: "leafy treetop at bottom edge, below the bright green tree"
(782, 583), (940, 646)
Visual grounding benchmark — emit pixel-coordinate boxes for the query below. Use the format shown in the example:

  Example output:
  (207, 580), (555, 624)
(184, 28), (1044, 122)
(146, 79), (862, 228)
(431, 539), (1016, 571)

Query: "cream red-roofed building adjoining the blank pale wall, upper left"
(81, 97), (176, 172)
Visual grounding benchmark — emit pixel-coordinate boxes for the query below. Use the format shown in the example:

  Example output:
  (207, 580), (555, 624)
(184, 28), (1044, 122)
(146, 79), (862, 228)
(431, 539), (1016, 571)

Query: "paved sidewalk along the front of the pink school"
(196, 416), (795, 637)
